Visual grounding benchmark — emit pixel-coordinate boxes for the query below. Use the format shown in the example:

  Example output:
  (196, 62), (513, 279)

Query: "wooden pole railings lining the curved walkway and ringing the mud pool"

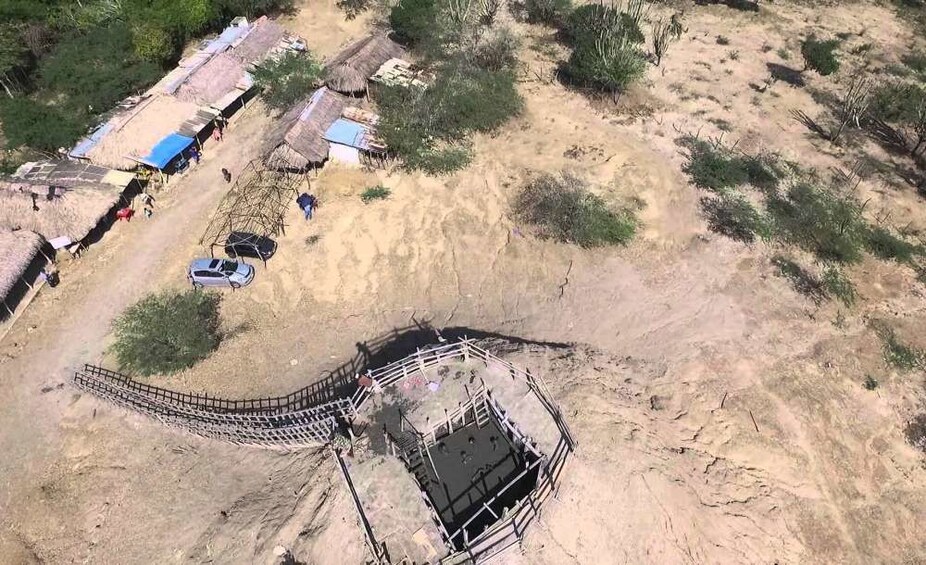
(74, 339), (576, 565)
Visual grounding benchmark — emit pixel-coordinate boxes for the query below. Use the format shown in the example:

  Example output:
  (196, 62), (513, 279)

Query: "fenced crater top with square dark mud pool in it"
(339, 339), (575, 564)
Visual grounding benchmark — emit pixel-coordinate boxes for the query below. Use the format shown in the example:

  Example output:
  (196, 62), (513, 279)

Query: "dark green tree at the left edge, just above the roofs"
(0, 97), (87, 152)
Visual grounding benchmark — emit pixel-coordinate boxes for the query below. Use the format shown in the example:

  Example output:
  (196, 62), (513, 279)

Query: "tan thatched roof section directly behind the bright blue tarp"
(86, 95), (203, 170)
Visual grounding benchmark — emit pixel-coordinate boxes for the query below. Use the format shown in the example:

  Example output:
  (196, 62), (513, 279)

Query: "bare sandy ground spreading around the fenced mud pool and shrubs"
(0, 2), (926, 564)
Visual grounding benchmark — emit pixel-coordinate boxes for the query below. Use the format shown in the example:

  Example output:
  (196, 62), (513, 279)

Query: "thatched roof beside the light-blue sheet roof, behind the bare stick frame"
(265, 87), (347, 169)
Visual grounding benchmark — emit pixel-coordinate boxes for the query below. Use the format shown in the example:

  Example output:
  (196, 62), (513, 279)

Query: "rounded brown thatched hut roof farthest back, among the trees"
(325, 34), (405, 94)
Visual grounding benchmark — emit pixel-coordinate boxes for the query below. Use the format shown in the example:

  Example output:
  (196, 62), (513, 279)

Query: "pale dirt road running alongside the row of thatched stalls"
(0, 107), (266, 549)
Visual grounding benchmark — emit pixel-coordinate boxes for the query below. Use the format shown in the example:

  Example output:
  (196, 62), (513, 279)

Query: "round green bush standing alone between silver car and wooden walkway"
(113, 290), (221, 375)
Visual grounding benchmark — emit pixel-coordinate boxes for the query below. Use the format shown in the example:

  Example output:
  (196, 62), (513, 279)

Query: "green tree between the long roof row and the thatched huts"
(252, 52), (322, 111)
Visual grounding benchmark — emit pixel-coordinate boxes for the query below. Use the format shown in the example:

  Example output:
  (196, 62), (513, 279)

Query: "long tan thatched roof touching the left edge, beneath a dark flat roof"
(0, 181), (122, 241)
